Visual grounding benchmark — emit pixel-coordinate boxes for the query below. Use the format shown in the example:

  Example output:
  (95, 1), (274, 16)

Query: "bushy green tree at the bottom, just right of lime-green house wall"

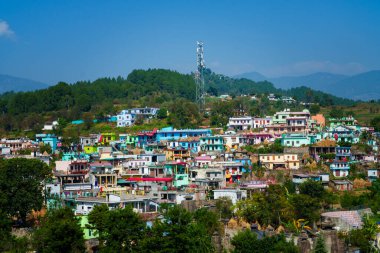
(88, 205), (145, 253)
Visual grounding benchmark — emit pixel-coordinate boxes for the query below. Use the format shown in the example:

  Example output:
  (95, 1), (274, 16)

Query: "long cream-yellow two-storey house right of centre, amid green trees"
(259, 154), (300, 170)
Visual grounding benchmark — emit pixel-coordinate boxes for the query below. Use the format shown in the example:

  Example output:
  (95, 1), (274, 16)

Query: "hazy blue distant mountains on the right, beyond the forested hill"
(234, 70), (380, 101)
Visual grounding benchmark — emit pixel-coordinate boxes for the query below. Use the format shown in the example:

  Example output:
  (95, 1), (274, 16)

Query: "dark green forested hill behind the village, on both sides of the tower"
(0, 69), (353, 131)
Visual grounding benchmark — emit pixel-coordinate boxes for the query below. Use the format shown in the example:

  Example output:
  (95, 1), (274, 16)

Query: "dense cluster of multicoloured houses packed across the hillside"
(0, 108), (380, 243)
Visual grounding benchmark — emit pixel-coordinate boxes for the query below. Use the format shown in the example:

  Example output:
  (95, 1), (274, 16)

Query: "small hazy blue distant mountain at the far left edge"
(0, 75), (49, 93)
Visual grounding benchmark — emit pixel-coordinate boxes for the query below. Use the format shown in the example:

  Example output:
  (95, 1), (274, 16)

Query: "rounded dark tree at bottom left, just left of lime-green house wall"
(33, 207), (85, 253)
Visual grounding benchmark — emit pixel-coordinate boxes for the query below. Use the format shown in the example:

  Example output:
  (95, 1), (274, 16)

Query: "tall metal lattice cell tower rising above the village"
(195, 41), (205, 112)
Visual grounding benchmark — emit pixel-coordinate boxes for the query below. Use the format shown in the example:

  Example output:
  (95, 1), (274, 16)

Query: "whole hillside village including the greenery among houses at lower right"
(0, 97), (380, 252)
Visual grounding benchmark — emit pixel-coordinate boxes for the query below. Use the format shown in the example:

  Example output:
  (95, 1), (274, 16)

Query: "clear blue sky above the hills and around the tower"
(0, 0), (380, 84)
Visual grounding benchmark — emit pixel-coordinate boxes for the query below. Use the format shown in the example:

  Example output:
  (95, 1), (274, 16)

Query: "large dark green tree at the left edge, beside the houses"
(0, 158), (51, 221)
